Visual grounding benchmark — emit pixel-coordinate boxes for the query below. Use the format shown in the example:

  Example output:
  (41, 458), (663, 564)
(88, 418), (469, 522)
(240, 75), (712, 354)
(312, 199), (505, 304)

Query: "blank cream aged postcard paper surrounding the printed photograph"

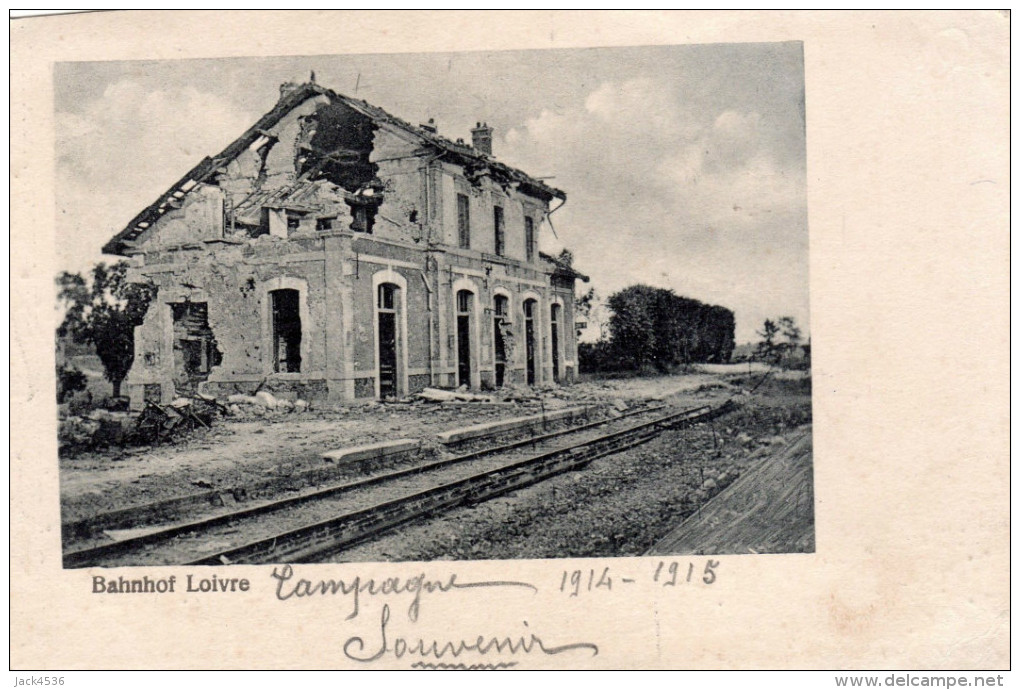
(10, 11), (1009, 669)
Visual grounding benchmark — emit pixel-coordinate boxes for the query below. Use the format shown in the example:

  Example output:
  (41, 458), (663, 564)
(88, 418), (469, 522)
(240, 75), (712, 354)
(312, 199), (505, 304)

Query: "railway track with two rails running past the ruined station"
(63, 402), (731, 568)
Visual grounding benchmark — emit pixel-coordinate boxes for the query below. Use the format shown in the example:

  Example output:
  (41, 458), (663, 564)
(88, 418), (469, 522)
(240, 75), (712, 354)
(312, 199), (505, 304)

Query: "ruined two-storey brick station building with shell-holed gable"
(103, 83), (588, 407)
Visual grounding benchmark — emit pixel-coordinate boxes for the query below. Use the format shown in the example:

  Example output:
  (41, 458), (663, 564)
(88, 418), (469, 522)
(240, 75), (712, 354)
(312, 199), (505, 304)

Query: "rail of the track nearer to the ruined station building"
(63, 398), (665, 568)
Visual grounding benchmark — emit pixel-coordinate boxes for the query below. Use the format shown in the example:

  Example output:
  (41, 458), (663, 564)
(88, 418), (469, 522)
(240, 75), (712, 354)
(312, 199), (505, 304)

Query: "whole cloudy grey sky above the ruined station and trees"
(54, 43), (809, 342)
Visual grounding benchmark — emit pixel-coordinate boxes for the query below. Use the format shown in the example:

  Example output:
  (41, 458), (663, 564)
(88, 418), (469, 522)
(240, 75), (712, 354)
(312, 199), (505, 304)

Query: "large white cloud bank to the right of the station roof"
(500, 79), (808, 340)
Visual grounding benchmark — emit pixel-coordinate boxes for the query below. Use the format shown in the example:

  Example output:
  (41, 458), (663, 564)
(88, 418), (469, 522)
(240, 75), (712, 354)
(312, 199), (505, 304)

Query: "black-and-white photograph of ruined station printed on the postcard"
(54, 42), (814, 568)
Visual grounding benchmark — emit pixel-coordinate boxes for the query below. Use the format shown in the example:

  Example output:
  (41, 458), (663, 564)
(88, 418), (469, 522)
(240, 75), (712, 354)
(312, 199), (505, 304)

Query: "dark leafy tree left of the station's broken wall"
(57, 261), (156, 397)
